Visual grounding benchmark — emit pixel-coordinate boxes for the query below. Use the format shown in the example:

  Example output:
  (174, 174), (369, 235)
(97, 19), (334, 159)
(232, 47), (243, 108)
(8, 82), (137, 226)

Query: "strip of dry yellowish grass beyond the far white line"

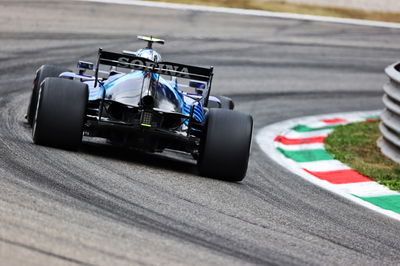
(145, 0), (400, 22)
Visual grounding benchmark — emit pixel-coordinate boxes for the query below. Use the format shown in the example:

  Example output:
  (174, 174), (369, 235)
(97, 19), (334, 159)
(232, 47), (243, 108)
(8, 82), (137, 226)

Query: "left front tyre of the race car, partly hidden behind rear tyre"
(26, 65), (70, 126)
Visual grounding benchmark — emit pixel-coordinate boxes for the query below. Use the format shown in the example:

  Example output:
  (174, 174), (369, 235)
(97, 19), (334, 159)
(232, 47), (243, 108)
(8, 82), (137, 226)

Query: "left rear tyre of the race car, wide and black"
(32, 78), (88, 150)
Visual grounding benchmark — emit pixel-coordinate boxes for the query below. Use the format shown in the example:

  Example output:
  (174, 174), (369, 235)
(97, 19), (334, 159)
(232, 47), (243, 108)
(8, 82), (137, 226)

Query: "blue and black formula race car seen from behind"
(26, 36), (253, 181)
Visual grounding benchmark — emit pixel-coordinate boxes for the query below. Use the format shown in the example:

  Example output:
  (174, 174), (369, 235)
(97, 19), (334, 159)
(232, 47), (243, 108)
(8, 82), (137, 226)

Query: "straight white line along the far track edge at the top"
(75, 0), (400, 29)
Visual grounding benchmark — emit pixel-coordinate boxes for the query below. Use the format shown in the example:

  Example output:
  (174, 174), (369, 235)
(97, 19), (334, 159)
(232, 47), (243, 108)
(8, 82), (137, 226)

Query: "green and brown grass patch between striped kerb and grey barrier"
(325, 121), (400, 191)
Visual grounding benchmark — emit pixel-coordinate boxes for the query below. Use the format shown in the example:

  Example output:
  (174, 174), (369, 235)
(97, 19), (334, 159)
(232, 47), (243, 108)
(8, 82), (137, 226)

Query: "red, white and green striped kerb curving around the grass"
(256, 111), (400, 221)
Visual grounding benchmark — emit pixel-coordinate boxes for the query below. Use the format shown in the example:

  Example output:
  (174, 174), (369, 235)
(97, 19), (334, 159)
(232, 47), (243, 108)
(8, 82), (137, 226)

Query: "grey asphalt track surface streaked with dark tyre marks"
(0, 0), (400, 265)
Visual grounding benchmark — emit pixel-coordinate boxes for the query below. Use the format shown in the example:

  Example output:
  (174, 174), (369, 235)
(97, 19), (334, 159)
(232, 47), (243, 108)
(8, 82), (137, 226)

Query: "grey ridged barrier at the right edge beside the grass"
(378, 62), (400, 163)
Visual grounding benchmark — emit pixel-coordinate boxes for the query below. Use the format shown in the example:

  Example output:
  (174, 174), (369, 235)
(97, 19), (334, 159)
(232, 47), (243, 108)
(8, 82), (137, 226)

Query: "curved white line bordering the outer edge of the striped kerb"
(256, 110), (400, 221)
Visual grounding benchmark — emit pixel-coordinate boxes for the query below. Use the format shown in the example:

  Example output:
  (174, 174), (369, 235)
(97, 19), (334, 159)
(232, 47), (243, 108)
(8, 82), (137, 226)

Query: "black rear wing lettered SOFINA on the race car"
(96, 49), (213, 82)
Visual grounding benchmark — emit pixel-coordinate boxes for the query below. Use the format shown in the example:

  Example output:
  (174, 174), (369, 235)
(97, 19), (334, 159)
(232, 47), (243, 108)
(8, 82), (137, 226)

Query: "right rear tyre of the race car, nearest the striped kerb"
(198, 109), (253, 182)
